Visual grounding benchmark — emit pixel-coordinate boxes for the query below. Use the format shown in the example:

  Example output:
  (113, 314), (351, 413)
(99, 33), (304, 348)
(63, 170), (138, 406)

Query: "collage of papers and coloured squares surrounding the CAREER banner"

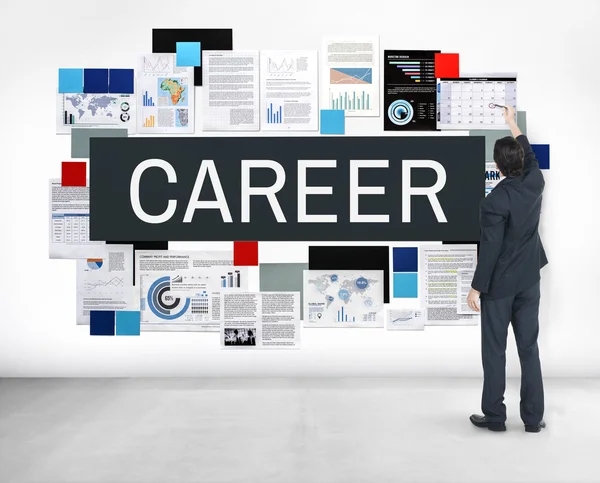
(54, 29), (549, 349)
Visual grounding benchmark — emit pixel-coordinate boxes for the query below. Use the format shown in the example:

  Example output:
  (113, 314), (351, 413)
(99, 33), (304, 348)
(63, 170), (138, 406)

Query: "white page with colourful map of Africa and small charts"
(137, 54), (194, 134)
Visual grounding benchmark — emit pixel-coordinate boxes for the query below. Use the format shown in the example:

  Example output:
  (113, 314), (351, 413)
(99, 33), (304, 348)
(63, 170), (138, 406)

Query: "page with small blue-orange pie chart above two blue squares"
(77, 245), (134, 325)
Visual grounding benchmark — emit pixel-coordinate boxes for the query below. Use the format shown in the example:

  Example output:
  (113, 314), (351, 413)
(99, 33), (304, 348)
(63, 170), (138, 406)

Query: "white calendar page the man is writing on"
(438, 74), (517, 129)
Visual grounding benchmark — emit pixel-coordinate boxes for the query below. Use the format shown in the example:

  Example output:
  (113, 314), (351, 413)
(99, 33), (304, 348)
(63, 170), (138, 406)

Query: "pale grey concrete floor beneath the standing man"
(0, 379), (600, 483)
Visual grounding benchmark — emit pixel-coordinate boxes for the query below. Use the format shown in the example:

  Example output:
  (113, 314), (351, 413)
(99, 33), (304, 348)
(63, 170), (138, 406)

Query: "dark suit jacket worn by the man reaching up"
(471, 135), (548, 299)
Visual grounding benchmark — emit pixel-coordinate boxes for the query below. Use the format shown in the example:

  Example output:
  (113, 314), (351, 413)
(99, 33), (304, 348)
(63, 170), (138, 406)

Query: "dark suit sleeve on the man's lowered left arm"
(471, 195), (508, 293)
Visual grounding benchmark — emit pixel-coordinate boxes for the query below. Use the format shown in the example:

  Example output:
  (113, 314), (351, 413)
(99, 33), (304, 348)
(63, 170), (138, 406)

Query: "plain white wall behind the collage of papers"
(0, 0), (600, 376)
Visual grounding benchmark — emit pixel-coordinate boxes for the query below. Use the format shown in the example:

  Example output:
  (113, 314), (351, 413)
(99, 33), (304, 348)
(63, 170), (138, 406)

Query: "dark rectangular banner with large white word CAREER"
(90, 136), (485, 241)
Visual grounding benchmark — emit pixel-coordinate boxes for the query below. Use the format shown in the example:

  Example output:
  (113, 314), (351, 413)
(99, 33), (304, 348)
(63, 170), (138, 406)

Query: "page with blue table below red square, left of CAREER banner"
(50, 179), (105, 258)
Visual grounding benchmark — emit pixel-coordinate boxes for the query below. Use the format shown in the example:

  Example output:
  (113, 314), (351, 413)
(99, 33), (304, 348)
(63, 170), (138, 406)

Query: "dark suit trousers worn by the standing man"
(481, 281), (544, 425)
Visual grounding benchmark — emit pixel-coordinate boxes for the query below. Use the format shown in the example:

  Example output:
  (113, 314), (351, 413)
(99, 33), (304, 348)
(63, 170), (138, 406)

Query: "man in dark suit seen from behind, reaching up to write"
(467, 107), (548, 433)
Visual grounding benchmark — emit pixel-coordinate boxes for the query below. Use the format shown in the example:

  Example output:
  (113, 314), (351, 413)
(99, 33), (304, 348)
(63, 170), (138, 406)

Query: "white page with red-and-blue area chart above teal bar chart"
(321, 36), (379, 116)
